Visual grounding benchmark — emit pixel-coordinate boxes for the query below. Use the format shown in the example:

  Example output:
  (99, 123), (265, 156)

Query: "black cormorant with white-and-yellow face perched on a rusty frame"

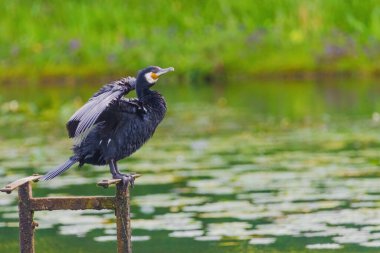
(42, 67), (174, 185)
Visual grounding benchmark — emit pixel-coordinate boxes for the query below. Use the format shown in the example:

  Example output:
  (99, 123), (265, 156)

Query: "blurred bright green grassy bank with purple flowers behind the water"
(0, 0), (380, 79)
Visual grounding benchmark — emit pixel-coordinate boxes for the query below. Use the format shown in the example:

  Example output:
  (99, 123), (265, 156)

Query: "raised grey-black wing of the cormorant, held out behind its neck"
(66, 77), (136, 138)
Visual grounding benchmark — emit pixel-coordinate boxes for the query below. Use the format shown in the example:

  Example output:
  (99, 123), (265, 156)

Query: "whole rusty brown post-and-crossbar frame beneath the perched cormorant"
(0, 175), (135, 253)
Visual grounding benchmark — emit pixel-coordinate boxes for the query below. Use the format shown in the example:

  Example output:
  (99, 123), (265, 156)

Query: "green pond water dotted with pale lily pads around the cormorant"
(0, 80), (380, 253)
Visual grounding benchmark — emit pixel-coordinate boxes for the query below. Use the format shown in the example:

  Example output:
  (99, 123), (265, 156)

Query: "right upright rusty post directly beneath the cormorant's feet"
(115, 184), (132, 253)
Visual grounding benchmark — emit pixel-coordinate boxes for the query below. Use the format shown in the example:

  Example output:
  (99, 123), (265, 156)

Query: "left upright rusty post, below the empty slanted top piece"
(18, 182), (36, 253)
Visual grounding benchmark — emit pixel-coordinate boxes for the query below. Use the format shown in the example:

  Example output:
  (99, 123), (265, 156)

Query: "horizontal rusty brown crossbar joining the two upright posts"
(30, 196), (115, 211)
